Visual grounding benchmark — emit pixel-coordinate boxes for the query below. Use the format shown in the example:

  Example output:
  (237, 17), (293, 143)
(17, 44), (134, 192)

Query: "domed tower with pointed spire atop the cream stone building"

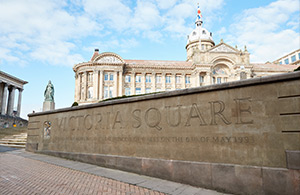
(185, 5), (215, 61)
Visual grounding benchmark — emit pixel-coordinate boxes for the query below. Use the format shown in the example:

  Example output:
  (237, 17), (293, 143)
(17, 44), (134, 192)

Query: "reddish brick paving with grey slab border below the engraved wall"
(0, 146), (227, 195)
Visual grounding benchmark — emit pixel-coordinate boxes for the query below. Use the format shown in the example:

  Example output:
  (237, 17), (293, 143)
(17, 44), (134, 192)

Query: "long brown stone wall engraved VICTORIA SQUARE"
(27, 72), (300, 194)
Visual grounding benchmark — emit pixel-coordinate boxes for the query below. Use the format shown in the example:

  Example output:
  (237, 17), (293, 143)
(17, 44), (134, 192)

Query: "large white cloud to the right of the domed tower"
(226, 0), (300, 62)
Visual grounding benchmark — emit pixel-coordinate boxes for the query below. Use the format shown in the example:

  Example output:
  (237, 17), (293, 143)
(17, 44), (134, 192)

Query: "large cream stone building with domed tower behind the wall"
(73, 8), (295, 104)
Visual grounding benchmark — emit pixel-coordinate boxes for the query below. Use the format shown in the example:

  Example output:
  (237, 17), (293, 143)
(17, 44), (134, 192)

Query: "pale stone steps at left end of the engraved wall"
(0, 133), (27, 148)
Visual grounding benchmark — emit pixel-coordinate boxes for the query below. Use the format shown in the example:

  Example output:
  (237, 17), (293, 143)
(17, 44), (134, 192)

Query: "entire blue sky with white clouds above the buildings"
(0, 0), (300, 118)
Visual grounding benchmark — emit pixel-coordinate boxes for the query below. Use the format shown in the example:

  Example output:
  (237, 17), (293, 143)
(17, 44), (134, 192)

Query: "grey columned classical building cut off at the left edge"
(0, 71), (28, 128)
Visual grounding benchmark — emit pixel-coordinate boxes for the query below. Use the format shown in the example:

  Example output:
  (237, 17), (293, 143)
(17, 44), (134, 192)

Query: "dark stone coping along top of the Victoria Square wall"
(28, 72), (300, 117)
